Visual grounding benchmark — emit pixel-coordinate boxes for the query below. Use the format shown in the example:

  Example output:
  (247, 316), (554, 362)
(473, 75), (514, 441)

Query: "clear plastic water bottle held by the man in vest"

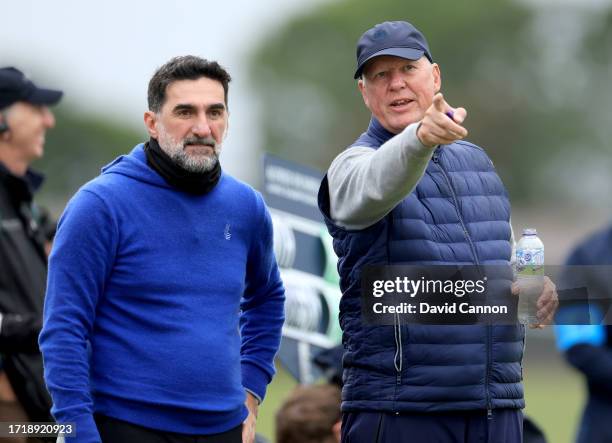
(516, 228), (544, 324)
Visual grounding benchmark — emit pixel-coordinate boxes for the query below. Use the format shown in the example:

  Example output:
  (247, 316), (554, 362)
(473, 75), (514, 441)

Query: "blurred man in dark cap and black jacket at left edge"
(0, 68), (62, 430)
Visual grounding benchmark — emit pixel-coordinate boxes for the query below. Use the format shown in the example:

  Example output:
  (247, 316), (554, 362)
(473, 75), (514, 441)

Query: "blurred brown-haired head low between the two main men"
(276, 384), (341, 443)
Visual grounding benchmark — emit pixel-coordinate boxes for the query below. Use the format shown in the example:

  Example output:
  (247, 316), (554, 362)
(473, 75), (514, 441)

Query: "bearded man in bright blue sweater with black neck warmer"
(40, 56), (284, 443)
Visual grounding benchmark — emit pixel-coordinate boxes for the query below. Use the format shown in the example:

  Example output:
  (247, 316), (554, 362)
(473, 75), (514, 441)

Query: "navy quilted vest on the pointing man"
(319, 119), (524, 412)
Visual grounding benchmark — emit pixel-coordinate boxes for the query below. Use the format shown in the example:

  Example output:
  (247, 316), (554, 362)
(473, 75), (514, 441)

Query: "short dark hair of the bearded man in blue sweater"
(147, 55), (232, 112)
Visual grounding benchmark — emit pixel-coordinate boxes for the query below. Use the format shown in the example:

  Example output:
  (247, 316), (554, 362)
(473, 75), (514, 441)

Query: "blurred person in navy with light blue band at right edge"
(555, 226), (612, 443)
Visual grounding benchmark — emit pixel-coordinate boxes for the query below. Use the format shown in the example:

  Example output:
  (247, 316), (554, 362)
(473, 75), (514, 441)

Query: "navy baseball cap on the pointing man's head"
(355, 22), (433, 78)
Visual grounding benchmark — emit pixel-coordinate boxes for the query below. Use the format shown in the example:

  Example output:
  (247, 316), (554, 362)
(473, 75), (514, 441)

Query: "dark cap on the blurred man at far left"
(0, 67), (63, 109)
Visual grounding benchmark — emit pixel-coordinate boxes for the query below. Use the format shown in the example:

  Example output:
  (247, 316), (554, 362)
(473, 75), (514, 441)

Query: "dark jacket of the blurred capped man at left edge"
(0, 164), (52, 421)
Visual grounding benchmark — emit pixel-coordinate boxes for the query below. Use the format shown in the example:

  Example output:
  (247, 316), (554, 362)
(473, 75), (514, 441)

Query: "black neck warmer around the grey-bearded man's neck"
(144, 138), (221, 195)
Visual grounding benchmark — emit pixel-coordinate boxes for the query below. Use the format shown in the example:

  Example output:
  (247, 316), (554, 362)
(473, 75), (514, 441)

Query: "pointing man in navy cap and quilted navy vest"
(319, 22), (557, 443)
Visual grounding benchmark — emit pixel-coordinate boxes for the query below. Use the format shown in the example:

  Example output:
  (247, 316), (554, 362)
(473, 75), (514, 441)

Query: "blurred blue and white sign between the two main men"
(264, 155), (341, 383)
